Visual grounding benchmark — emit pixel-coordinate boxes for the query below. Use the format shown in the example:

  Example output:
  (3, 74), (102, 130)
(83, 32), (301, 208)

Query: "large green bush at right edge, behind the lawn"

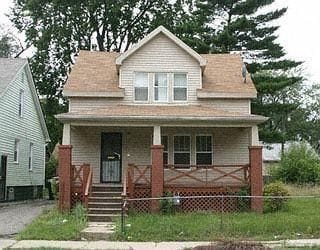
(272, 143), (320, 184)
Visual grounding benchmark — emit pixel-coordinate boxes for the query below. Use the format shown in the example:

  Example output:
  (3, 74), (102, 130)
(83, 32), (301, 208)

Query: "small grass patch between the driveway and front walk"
(16, 206), (87, 240)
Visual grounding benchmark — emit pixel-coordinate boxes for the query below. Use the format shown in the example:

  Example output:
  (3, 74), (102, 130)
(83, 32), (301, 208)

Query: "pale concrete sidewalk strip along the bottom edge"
(0, 239), (320, 250)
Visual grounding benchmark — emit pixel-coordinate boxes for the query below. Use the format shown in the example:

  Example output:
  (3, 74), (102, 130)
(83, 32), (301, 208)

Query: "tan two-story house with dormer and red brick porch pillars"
(57, 26), (266, 220)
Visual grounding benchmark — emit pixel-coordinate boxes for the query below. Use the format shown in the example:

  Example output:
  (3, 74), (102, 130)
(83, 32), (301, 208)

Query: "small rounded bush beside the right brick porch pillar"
(263, 182), (289, 212)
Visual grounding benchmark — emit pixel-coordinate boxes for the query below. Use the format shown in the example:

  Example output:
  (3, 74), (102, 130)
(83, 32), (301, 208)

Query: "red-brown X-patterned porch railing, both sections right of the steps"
(124, 164), (250, 194)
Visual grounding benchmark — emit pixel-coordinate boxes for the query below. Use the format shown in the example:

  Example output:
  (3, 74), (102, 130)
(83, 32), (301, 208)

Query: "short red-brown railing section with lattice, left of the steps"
(71, 164), (92, 207)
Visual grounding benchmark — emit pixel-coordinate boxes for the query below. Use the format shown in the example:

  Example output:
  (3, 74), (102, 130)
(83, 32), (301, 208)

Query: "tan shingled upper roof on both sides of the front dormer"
(63, 50), (257, 98)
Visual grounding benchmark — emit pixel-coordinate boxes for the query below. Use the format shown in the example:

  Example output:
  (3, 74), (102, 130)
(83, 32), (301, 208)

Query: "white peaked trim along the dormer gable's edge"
(116, 26), (207, 68)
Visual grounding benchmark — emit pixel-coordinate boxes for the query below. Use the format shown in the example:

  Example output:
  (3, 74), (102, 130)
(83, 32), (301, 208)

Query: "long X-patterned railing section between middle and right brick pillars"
(164, 165), (250, 187)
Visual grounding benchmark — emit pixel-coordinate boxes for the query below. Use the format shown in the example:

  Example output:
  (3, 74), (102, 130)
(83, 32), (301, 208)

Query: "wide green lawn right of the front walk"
(113, 195), (320, 241)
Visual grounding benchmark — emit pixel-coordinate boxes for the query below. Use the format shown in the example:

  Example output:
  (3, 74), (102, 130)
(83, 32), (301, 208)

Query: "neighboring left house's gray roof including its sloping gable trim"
(0, 58), (50, 142)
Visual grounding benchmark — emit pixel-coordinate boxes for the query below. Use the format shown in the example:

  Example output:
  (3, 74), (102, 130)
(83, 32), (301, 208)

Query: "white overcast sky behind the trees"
(0, 0), (320, 84)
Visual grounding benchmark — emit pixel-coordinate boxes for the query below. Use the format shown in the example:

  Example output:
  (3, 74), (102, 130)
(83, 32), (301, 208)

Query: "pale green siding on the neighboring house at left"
(0, 67), (45, 186)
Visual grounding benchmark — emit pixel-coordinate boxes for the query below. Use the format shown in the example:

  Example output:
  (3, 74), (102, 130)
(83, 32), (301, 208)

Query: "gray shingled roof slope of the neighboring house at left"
(0, 58), (28, 96)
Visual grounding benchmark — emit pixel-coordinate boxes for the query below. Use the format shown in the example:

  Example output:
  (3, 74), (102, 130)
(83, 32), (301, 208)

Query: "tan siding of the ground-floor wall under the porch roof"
(71, 127), (249, 183)
